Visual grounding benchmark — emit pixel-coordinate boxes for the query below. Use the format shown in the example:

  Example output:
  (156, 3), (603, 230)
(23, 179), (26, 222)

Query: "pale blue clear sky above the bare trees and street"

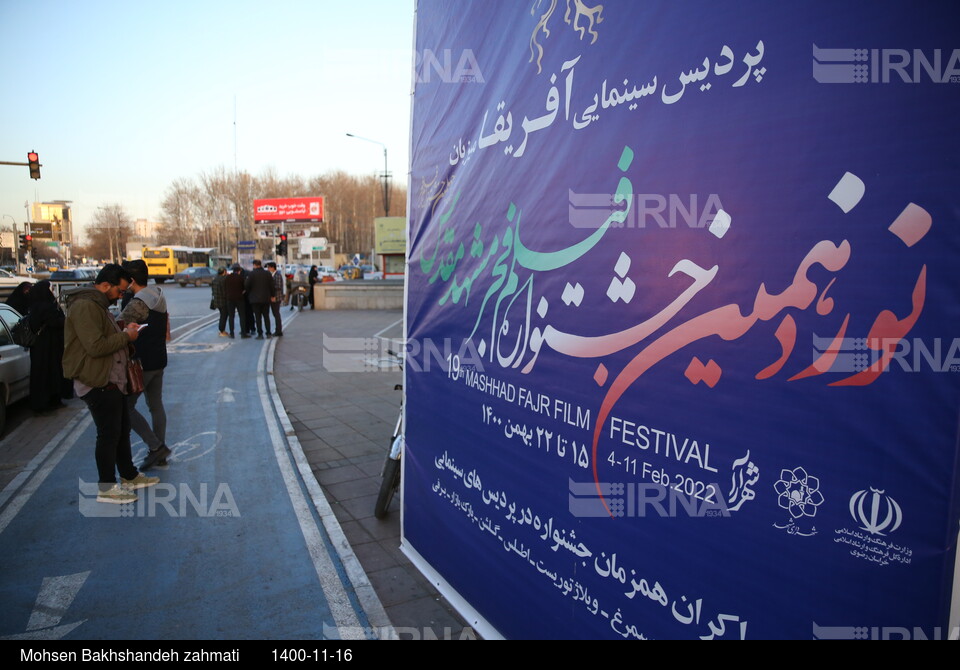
(0, 0), (414, 242)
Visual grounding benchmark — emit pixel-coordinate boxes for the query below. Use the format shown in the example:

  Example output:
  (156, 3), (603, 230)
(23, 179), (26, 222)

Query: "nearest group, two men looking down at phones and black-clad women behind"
(7, 260), (171, 503)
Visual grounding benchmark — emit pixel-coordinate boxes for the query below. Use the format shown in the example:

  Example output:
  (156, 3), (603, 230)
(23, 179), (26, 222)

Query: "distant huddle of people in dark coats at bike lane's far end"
(210, 260), (286, 340)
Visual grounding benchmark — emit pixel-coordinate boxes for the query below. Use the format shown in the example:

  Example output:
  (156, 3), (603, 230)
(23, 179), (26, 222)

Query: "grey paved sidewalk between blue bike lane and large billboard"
(274, 309), (473, 640)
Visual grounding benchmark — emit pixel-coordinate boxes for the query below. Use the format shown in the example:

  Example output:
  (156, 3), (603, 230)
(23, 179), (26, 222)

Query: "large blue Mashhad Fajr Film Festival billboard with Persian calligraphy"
(403, 0), (960, 639)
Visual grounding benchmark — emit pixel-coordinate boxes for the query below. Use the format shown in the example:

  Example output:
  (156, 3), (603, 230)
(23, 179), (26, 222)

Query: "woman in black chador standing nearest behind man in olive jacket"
(28, 280), (73, 412)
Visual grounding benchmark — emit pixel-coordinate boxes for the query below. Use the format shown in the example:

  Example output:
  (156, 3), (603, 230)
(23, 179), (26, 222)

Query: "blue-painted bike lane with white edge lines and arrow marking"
(0, 285), (367, 640)
